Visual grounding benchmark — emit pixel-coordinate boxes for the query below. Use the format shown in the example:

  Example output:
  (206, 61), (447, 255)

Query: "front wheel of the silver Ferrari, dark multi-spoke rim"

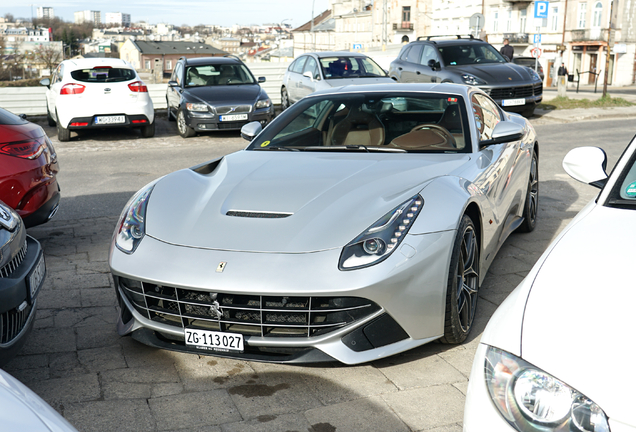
(440, 215), (479, 343)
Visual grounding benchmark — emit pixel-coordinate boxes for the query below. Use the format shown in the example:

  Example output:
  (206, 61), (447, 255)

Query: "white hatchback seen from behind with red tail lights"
(40, 58), (155, 141)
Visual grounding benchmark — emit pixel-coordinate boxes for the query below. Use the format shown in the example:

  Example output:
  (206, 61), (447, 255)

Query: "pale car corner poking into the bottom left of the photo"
(0, 369), (77, 432)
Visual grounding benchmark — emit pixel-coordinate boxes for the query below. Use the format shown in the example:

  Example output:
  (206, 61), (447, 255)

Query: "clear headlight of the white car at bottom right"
(484, 347), (610, 432)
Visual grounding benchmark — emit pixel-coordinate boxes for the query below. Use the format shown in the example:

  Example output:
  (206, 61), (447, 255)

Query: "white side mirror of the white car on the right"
(563, 147), (607, 189)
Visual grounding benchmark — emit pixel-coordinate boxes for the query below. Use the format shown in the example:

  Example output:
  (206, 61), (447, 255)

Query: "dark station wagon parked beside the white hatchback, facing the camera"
(166, 56), (274, 138)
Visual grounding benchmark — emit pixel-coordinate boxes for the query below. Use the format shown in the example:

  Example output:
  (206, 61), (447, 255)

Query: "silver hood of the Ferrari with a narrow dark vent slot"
(146, 151), (470, 253)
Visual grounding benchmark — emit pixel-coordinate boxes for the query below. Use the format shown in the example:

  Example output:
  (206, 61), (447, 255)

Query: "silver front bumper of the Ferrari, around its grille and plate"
(110, 231), (455, 364)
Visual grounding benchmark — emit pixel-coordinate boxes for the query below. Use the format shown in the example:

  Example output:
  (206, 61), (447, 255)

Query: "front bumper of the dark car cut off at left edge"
(0, 236), (46, 366)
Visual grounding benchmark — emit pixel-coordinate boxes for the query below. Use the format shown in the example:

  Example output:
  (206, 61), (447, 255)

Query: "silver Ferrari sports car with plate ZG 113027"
(109, 83), (539, 364)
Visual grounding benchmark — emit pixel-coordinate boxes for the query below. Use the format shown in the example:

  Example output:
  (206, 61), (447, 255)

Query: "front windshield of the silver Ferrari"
(247, 92), (470, 153)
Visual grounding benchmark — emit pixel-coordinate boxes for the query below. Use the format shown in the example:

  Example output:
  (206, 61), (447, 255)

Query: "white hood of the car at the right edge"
(521, 206), (636, 426)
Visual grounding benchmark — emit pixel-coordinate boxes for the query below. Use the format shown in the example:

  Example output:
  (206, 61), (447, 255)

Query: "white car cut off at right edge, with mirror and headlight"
(464, 140), (636, 432)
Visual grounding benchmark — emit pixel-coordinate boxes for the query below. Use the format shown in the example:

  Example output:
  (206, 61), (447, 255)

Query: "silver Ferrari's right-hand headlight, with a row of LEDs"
(338, 195), (424, 270)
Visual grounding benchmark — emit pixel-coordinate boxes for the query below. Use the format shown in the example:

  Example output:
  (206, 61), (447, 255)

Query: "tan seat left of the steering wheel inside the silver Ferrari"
(331, 107), (384, 146)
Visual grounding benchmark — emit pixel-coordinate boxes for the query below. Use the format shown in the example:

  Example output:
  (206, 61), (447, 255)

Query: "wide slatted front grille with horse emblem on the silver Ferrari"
(119, 278), (380, 338)
